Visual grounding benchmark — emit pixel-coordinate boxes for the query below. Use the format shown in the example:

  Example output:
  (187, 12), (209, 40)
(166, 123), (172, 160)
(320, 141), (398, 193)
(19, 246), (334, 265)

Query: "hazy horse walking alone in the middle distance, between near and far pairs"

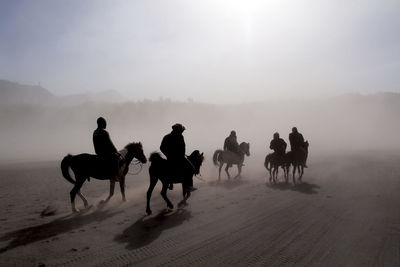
(213, 142), (250, 181)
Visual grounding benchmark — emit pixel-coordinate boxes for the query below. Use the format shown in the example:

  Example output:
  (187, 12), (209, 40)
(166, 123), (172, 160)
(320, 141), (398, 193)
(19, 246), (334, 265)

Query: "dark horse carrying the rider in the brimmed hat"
(146, 150), (204, 215)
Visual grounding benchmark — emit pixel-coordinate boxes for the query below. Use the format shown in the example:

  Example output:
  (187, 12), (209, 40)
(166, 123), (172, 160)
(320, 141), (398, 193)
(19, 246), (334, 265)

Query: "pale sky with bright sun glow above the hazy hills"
(0, 0), (400, 103)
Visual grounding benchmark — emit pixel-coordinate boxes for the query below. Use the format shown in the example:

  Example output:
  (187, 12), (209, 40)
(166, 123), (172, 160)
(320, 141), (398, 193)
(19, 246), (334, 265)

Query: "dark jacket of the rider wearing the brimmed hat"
(160, 130), (186, 160)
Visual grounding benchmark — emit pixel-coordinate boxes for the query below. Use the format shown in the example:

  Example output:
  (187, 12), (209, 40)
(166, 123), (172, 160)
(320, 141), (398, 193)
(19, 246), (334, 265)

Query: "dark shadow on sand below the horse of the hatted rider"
(115, 209), (192, 249)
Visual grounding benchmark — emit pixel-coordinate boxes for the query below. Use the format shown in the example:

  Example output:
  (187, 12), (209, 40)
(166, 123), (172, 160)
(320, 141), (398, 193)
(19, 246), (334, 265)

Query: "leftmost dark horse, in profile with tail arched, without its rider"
(61, 143), (147, 212)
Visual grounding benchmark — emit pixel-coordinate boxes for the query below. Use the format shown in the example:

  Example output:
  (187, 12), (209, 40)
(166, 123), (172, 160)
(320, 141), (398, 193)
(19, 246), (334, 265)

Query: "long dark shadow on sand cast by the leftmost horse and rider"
(0, 209), (122, 254)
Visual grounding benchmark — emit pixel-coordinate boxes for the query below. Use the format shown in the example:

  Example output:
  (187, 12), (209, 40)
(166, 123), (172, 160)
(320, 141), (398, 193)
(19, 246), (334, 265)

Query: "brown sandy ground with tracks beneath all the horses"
(0, 152), (400, 266)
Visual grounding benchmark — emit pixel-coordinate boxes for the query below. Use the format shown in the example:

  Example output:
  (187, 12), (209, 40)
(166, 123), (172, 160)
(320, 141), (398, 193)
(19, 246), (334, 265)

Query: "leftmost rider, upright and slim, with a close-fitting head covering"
(93, 117), (121, 181)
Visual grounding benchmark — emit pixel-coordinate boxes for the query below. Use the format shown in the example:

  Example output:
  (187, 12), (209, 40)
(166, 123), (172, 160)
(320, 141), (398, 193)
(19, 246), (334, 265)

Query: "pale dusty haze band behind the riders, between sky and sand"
(0, 93), (400, 162)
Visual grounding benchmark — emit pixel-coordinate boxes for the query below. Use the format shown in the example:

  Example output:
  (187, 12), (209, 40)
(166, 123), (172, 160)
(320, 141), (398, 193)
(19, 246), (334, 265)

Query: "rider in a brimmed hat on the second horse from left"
(160, 123), (197, 192)
